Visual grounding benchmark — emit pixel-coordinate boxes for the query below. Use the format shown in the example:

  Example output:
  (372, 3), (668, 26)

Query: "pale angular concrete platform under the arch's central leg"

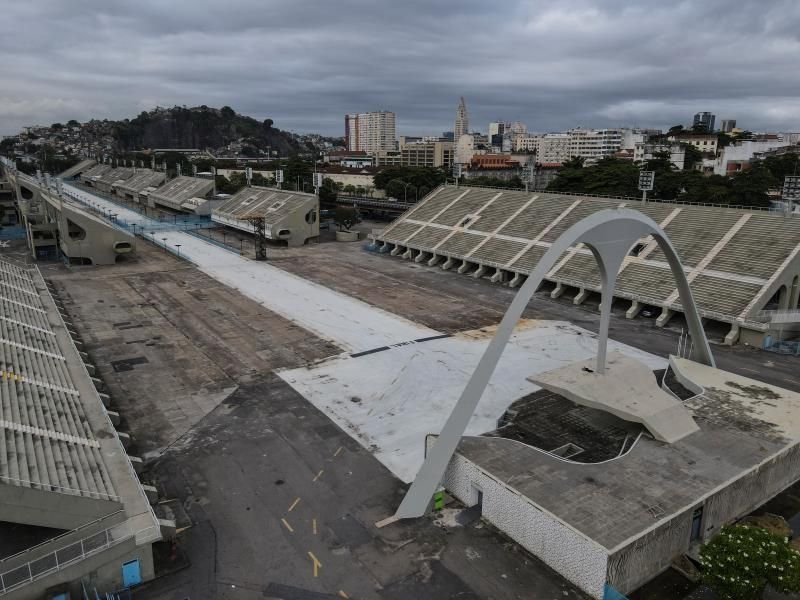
(528, 351), (699, 444)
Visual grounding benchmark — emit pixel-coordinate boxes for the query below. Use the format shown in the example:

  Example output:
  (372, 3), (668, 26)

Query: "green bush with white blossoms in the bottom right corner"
(700, 525), (800, 600)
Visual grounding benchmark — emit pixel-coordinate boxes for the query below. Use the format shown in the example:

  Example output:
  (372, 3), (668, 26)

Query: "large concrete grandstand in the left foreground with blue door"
(0, 260), (167, 598)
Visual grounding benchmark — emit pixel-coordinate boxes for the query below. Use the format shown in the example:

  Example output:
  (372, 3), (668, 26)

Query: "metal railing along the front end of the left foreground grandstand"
(0, 521), (161, 596)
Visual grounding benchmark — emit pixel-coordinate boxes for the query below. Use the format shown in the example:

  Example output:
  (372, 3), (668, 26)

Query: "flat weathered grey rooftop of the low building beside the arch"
(458, 358), (800, 551)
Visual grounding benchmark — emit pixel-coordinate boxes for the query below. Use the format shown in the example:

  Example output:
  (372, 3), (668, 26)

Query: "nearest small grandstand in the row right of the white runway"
(216, 187), (319, 247)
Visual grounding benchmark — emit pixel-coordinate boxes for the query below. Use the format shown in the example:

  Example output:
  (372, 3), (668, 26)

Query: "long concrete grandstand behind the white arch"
(373, 186), (800, 344)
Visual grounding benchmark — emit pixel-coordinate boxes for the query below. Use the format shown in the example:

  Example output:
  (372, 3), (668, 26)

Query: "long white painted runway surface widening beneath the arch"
(65, 183), (666, 482)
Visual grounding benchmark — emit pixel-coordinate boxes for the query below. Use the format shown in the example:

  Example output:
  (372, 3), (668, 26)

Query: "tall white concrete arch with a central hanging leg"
(390, 208), (715, 520)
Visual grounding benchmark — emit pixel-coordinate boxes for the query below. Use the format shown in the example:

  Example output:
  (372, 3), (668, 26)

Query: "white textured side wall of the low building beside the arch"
(444, 454), (608, 599)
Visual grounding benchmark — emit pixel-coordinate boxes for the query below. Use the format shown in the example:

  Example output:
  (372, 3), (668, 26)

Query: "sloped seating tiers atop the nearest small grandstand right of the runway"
(214, 186), (317, 224)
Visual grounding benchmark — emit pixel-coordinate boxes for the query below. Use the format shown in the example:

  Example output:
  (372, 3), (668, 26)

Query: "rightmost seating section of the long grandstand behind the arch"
(708, 214), (800, 279)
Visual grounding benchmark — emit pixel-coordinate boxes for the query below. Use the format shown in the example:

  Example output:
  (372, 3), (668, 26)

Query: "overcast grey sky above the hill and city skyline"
(0, 0), (800, 135)
